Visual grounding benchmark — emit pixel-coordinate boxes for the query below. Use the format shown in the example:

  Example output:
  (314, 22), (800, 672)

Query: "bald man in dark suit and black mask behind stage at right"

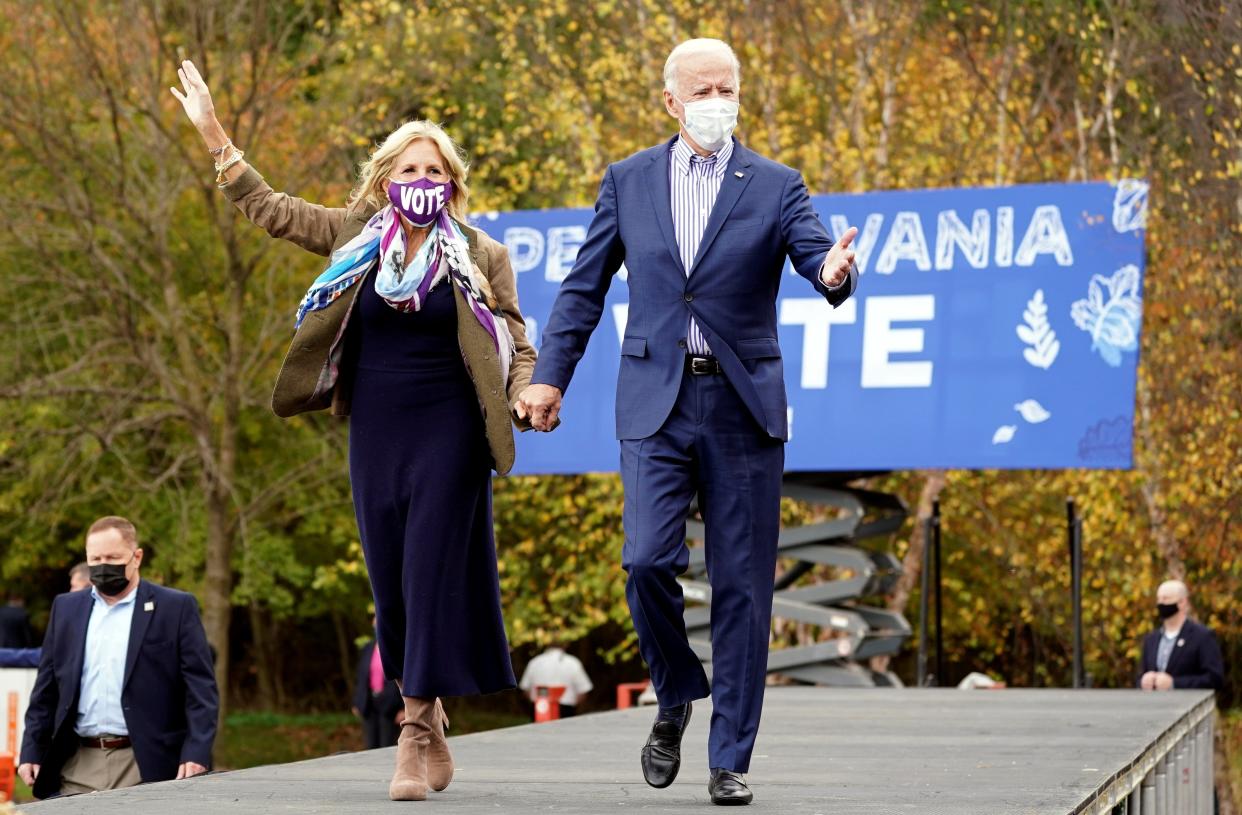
(1139, 580), (1225, 691)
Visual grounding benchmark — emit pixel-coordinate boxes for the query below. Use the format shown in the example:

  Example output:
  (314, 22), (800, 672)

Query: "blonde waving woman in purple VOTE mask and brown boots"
(173, 61), (535, 800)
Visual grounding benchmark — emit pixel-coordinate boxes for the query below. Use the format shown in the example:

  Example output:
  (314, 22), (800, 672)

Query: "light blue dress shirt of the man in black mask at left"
(73, 586), (138, 737)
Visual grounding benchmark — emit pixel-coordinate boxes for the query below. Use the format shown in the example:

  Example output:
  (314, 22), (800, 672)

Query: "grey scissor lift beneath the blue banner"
(681, 472), (910, 687)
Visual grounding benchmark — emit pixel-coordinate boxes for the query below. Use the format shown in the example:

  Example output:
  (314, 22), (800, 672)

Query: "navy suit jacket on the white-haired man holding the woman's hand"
(532, 139), (858, 440)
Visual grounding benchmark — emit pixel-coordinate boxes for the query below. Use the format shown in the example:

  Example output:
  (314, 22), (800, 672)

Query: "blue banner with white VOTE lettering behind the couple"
(476, 179), (1148, 473)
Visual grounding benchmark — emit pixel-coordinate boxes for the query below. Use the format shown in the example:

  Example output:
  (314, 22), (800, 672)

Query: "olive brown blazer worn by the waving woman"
(220, 166), (535, 476)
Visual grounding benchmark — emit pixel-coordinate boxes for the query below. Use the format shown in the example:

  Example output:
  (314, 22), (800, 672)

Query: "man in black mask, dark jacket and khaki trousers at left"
(17, 516), (220, 798)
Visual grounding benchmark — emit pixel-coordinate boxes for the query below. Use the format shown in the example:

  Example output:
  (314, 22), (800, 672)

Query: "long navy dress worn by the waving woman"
(349, 264), (515, 697)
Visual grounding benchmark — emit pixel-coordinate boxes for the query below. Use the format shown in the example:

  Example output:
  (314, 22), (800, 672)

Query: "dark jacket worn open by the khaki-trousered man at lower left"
(21, 580), (220, 798)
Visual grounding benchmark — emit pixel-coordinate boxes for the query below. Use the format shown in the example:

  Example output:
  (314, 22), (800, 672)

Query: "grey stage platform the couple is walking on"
(22, 687), (1212, 815)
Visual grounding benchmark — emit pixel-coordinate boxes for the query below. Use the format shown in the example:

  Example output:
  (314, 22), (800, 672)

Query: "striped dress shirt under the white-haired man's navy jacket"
(668, 137), (733, 357)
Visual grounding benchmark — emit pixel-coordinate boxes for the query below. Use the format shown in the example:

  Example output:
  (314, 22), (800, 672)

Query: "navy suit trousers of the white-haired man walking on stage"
(621, 373), (785, 773)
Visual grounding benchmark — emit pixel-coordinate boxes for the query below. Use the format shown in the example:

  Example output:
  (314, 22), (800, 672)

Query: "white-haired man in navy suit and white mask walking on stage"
(519, 40), (857, 804)
